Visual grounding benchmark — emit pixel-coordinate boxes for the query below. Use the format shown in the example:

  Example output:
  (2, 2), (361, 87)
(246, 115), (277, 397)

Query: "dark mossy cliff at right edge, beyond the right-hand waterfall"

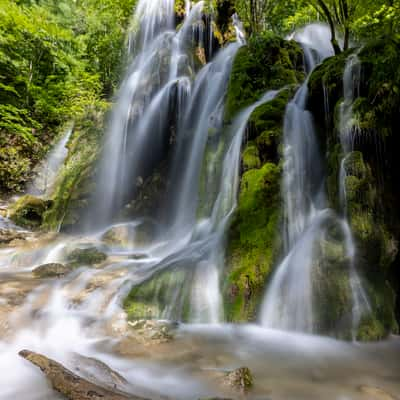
(308, 38), (400, 340)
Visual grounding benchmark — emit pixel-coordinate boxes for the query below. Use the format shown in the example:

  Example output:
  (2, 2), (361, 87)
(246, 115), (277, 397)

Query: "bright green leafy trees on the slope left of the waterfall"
(0, 0), (135, 192)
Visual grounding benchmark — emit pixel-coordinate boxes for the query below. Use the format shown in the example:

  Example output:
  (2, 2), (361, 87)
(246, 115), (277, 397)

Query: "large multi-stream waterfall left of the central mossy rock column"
(81, 0), (253, 323)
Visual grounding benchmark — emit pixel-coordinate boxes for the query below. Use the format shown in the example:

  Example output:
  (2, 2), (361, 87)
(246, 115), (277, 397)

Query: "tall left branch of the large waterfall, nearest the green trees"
(88, 0), (203, 226)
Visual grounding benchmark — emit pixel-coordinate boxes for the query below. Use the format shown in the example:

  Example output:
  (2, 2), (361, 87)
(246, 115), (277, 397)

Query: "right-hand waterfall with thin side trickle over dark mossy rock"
(260, 25), (366, 333)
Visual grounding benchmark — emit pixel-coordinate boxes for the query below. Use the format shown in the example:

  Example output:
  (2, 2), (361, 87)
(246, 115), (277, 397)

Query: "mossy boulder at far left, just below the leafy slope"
(9, 195), (53, 229)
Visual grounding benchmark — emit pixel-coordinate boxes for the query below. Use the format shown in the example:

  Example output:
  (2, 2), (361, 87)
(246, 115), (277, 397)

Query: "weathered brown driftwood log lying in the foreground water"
(19, 350), (146, 400)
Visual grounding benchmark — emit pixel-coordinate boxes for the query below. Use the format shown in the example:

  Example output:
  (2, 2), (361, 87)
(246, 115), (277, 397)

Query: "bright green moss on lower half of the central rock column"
(224, 163), (281, 321)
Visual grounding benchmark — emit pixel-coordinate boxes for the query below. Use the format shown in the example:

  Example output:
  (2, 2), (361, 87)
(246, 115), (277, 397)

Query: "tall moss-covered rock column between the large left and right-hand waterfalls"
(222, 34), (304, 322)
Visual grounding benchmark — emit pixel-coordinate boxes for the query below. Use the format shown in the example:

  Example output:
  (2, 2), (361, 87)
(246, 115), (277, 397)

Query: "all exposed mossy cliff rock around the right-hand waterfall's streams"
(223, 36), (400, 340)
